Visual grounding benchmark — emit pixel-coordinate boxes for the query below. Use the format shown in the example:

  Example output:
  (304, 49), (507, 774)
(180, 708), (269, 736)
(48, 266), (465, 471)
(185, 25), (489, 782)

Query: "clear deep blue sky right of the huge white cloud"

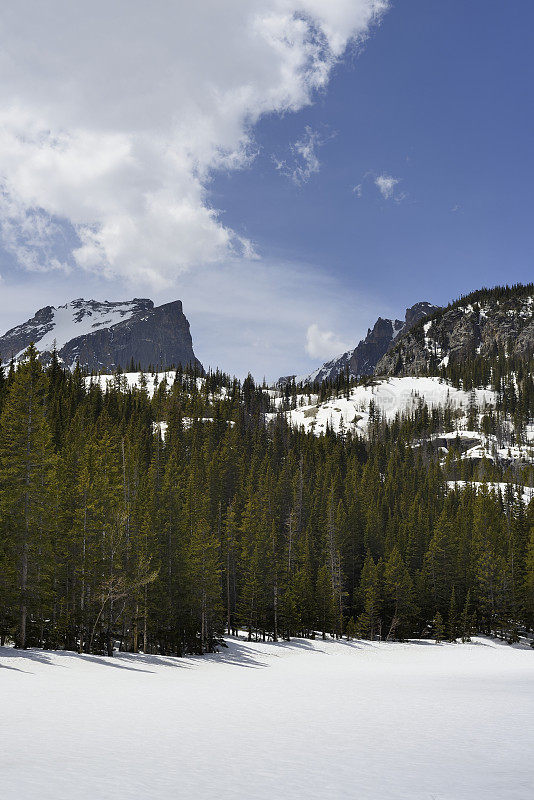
(212, 0), (534, 311)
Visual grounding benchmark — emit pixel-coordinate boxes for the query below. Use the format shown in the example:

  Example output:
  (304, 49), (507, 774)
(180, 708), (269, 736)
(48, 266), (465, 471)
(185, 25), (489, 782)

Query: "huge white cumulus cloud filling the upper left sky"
(0, 0), (389, 286)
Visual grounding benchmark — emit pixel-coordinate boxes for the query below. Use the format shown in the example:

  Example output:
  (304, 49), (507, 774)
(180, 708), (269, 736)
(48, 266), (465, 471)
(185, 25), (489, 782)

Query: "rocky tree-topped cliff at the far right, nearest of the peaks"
(375, 291), (534, 376)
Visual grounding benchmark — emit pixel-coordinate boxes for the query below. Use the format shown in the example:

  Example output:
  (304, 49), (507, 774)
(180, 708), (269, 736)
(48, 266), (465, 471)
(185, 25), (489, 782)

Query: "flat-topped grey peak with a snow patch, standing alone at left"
(0, 299), (202, 372)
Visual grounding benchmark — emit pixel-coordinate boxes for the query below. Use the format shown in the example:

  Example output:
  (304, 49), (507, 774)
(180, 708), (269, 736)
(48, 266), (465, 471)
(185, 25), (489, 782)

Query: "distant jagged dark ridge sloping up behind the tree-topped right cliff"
(286, 302), (439, 385)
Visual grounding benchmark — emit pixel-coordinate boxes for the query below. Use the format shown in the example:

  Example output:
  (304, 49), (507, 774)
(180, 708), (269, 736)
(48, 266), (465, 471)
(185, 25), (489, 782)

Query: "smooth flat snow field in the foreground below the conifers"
(0, 639), (534, 800)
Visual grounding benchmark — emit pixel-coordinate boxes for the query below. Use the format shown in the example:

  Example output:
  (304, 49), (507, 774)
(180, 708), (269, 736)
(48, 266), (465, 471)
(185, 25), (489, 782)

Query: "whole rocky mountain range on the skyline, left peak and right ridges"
(0, 284), (534, 386)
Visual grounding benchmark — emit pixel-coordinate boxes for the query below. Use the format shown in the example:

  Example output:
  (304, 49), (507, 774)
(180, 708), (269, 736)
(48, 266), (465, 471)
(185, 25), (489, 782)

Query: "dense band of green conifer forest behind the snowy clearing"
(0, 347), (534, 655)
